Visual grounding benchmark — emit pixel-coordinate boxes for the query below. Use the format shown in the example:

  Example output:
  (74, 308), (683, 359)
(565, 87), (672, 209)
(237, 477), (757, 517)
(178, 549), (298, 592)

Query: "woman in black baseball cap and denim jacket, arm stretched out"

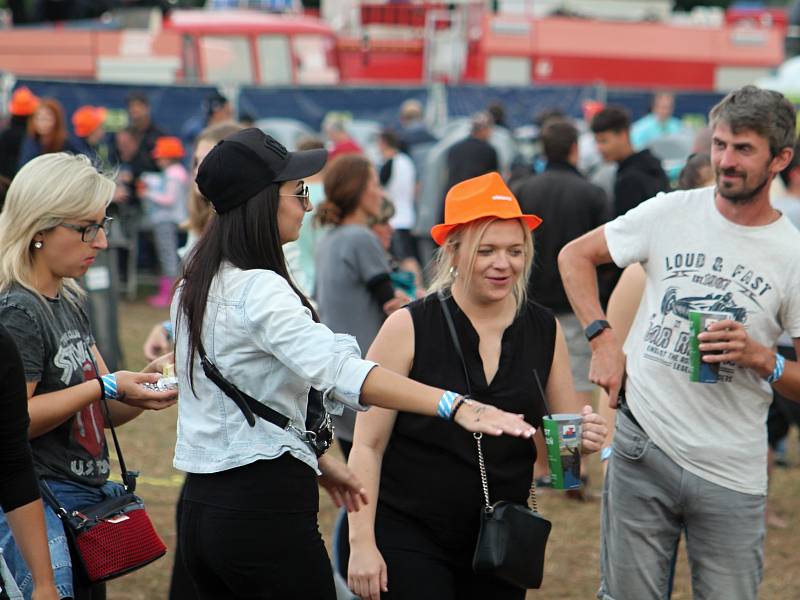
(172, 129), (533, 599)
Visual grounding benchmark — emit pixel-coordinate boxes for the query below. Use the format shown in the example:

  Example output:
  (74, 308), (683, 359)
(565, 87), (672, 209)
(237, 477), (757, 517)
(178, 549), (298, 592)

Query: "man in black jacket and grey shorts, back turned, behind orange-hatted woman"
(511, 118), (608, 404)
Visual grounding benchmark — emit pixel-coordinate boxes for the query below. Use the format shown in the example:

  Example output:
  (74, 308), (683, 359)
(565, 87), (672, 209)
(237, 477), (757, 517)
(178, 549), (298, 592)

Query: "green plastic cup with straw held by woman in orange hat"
(542, 413), (583, 490)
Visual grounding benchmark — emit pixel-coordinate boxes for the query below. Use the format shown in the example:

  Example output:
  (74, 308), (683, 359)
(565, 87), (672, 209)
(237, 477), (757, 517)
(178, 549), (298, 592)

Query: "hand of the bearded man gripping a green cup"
(697, 319), (775, 377)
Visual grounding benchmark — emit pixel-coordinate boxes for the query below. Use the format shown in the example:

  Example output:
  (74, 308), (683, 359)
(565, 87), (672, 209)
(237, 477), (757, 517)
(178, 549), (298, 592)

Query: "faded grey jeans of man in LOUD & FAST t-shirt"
(597, 411), (766, 600)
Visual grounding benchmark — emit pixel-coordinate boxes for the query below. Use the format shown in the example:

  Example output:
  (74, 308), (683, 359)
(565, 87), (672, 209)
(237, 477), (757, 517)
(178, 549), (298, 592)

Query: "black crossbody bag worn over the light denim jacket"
(197, 343), (333, 457)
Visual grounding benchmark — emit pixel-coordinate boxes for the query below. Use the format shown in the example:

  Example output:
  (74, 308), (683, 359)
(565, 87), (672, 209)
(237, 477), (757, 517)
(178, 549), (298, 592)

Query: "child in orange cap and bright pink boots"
(141, 136), (189, 307)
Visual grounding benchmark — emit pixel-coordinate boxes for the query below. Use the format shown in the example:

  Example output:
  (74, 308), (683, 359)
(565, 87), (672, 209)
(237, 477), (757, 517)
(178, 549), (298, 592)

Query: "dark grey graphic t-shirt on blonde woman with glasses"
(0, 286), (109, 485)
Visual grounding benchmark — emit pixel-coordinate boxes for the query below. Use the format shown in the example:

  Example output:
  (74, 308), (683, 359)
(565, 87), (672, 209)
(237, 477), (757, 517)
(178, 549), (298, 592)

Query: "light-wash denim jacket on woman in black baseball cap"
(171, 264), (376, 473)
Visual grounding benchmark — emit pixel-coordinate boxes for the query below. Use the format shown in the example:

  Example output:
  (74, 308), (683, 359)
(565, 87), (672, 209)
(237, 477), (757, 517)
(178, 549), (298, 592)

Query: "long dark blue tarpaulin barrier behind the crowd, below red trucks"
(14, 80), (722, 135)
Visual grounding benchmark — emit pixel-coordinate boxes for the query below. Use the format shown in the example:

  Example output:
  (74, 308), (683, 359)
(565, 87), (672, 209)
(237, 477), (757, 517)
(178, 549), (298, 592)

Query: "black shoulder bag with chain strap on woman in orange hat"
(438, 292), (551, 589)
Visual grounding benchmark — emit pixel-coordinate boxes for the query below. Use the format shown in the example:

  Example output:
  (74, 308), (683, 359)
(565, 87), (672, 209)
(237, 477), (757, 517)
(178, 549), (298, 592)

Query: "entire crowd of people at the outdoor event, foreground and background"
(0, 86), (800, 600)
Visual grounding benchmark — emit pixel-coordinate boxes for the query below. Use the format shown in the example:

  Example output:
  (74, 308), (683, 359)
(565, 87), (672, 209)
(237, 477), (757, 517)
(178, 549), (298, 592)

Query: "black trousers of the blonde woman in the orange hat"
(375, 505), (526, 600)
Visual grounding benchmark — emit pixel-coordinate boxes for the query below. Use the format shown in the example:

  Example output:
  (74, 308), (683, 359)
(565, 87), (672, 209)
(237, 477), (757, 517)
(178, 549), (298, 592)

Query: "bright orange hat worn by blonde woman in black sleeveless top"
(431, 172), (542, 246)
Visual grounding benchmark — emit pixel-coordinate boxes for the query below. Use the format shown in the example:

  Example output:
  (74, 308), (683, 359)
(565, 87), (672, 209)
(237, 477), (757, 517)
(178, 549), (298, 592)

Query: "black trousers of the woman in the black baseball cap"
(179, 454), (336, 600)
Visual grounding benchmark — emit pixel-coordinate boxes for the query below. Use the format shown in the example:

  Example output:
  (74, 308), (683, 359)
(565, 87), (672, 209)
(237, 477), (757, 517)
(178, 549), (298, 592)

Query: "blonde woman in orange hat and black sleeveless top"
(348, 173), (606, 600)
